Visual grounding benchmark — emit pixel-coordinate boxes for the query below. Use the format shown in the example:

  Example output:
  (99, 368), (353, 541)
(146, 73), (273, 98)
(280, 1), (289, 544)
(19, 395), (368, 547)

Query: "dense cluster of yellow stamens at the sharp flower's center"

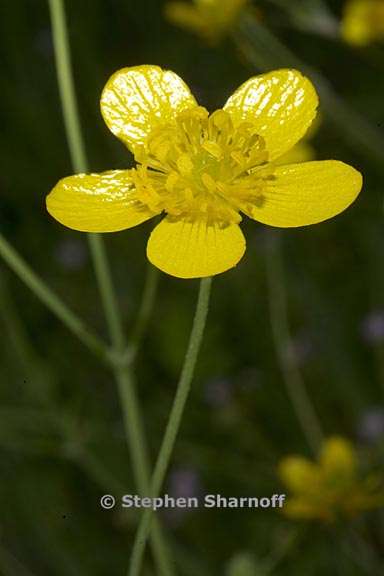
(134, 107), (272, 225)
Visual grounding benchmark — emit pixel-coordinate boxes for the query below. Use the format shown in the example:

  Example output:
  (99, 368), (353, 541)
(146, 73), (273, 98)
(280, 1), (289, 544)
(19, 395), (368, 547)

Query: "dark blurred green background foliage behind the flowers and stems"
(0, 0), (384, 576)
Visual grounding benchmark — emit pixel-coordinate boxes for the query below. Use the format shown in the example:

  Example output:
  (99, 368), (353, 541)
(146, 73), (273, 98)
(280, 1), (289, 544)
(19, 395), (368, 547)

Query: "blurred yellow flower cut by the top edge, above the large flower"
(165, 0), (248, 43)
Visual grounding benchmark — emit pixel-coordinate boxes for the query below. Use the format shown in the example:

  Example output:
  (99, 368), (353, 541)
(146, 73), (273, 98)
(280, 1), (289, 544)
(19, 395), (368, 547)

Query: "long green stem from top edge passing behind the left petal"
(49, 0), (173, 575)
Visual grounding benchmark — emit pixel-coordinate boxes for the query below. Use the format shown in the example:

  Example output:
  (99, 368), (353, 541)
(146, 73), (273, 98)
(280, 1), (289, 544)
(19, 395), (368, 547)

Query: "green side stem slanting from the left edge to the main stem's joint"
(0, 234), (108, 361)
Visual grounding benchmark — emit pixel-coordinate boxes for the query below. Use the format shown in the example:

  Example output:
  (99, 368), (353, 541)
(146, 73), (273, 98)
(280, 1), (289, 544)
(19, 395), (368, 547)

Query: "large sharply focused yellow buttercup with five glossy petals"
(47, 66), (362, 278)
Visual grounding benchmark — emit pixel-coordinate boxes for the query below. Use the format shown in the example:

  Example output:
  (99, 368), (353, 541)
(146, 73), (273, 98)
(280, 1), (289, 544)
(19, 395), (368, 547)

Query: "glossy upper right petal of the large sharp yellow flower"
(224, 70), (318, 160)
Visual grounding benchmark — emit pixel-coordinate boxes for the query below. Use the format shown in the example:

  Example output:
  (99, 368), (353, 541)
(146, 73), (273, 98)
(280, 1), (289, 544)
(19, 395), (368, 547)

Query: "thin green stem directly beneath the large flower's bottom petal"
(128, 278), (212, 576)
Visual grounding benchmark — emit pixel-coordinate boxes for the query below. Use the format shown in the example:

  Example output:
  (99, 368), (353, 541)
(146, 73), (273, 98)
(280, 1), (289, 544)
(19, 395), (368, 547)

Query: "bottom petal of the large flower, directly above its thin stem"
(147, 218), (245, 278)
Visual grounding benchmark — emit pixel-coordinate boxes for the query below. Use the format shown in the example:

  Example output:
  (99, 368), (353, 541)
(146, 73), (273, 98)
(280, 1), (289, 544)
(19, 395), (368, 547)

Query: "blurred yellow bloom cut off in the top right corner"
(341, 0), (384, 46)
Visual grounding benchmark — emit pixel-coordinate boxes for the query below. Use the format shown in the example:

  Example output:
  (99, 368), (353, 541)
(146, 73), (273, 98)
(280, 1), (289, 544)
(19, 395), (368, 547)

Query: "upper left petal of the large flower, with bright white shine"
(100, 66), (197, 151)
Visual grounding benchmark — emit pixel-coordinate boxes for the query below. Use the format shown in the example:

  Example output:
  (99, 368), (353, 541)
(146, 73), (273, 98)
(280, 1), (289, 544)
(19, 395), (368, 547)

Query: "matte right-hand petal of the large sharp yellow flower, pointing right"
(246, 160), (362, 228)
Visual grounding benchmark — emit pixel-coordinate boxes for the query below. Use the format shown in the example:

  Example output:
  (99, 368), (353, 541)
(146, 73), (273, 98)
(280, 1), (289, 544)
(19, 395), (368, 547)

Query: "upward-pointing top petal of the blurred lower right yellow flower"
(320, 437), (358, 481)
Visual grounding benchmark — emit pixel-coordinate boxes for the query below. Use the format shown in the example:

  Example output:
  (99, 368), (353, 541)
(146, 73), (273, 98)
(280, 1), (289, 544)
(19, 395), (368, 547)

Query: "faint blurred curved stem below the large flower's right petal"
(266, 239), (323, 455)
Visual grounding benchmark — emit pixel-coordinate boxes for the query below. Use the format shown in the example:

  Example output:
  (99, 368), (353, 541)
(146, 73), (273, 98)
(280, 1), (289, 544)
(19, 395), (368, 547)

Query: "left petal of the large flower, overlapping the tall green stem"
(47, 170), (155, 232)
